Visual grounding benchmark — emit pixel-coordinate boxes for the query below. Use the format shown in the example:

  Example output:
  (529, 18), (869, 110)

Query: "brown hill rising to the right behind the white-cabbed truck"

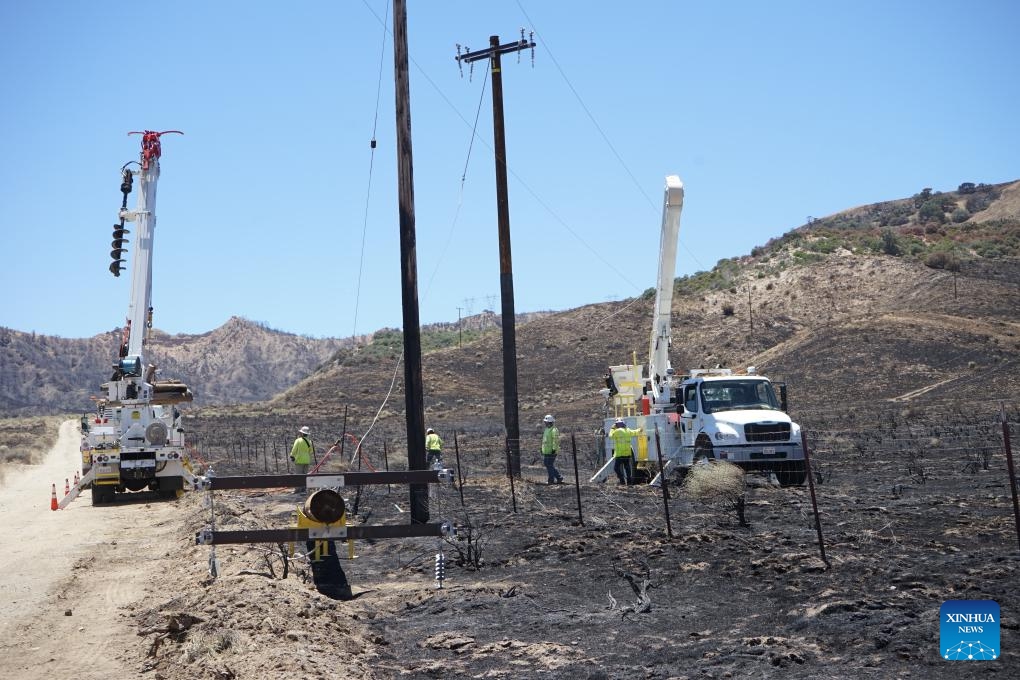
(198, 182), (1020, 452)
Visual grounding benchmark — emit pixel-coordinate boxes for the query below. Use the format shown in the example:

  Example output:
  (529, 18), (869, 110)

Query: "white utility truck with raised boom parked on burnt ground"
(592, 175), (807, 486)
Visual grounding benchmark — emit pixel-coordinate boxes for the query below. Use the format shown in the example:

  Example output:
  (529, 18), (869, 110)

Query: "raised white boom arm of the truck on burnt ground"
(648, 174), (683, 402)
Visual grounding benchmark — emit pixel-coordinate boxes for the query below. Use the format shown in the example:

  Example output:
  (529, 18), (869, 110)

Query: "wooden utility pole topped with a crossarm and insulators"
(457, 29), (534, 477)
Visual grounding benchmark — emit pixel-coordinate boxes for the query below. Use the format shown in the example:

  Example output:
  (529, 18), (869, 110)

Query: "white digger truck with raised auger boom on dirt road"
(81, 130), (196, 505)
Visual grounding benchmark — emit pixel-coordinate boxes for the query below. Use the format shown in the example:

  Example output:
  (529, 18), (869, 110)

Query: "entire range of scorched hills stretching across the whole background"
(0, 181), (1020, 438)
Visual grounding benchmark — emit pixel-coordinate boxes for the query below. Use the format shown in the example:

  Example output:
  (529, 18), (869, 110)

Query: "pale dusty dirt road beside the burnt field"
(0, 420), (175, 680)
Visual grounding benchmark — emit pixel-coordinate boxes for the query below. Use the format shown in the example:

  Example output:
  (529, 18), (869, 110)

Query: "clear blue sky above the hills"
(0, 0), (1020, 337)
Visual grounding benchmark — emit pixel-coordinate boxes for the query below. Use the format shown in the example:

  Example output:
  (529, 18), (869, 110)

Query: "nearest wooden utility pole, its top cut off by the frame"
(393, 0), (428, 524)
